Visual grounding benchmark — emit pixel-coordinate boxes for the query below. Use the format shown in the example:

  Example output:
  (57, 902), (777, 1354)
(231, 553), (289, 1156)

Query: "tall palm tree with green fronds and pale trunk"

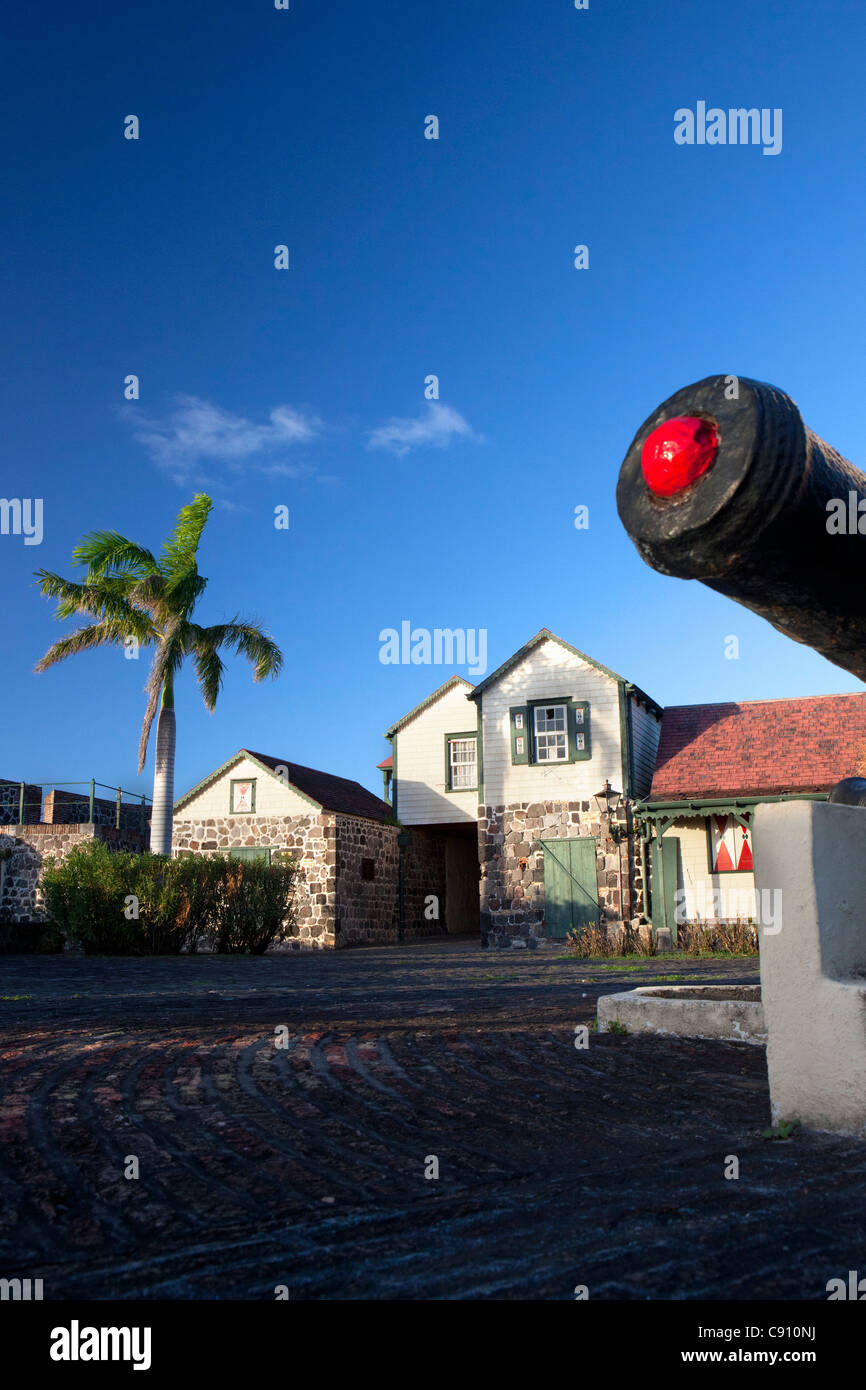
(36, 492), (282, 855)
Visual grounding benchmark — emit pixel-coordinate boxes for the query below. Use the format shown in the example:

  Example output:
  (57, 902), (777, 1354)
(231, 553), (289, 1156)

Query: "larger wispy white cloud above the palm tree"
(127, 396), (321, 482)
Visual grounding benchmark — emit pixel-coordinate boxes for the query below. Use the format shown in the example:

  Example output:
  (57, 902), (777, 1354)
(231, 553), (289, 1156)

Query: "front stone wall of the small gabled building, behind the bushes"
(171, 808), (336, 951)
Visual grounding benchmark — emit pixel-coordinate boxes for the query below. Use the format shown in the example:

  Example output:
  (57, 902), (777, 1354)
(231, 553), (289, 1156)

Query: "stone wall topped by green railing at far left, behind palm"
(0, 824), (146, 922)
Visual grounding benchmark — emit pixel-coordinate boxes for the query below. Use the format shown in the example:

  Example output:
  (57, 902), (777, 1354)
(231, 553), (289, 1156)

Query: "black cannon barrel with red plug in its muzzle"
(616, 375), (866, 680)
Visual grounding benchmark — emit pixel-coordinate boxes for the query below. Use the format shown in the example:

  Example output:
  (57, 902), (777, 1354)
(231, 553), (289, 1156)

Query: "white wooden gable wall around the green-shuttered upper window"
(481, 641), (623, 806)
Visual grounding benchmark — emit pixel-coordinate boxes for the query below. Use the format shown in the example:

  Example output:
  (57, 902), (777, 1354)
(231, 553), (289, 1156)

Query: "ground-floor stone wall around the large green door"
(478, 801), (637, 945)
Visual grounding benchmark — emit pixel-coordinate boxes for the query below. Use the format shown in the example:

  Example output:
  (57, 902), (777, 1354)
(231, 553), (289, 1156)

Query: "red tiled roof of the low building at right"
(648, 694), (866, 801)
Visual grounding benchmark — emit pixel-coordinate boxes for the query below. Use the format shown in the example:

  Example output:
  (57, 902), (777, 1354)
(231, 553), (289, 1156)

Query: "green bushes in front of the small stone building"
(42, 840), (297, 955)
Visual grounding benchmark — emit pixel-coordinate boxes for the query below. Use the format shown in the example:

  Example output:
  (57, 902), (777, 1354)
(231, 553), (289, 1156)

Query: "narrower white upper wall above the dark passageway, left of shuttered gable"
(395, 685), (478, 826)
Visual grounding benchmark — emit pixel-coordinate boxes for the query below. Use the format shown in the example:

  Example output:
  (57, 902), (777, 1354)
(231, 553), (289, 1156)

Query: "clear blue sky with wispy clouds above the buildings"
(0, 0), (866, 792)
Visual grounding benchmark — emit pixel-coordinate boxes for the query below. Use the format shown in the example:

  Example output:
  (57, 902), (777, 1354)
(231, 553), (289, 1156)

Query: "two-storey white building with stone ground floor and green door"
(384, 628), (662, 947)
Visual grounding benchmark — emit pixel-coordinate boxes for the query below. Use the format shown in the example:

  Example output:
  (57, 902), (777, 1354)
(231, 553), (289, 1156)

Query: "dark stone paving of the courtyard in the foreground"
(0, 938), (866, 1300)
